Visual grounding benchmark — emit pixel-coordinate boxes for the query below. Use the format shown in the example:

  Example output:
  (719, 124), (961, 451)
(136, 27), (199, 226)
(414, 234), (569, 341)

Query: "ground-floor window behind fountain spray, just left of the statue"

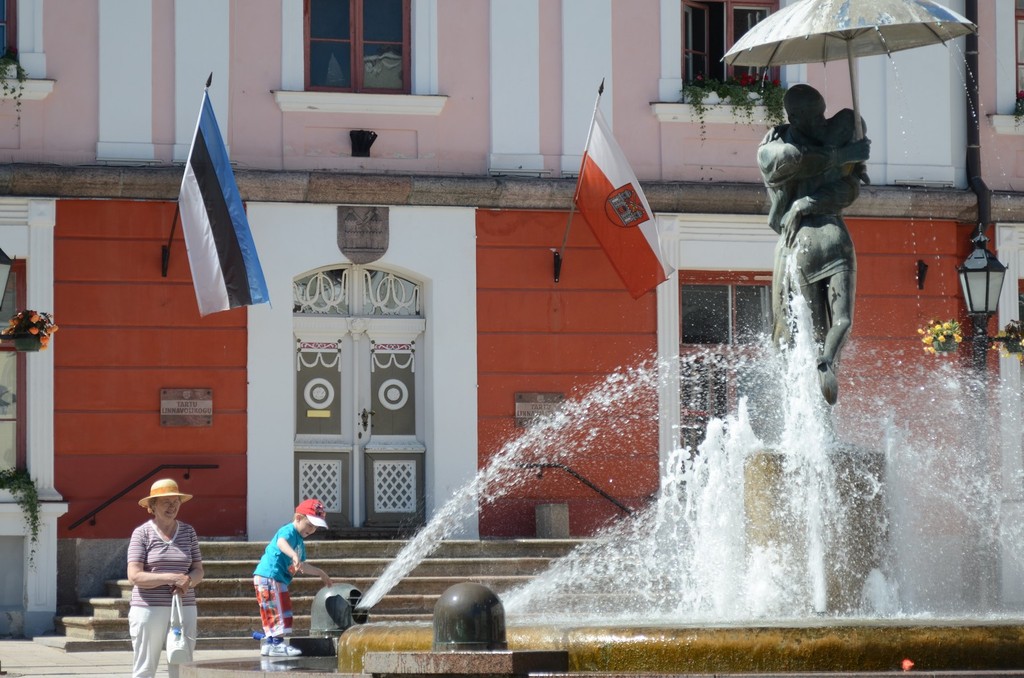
(679, 284), (771, 450)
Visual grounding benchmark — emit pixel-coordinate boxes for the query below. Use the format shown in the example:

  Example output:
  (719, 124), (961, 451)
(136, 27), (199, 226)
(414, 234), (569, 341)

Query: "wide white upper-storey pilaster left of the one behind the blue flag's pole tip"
(96, 0), (155, 162)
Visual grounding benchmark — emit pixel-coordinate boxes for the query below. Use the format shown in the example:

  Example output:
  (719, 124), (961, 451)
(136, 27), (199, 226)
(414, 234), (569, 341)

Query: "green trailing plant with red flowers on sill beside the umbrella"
(682, 74), (785, 139)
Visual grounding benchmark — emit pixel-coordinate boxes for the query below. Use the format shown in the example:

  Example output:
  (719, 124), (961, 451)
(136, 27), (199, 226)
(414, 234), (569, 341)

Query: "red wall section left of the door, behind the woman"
(53, 201), (247, 539)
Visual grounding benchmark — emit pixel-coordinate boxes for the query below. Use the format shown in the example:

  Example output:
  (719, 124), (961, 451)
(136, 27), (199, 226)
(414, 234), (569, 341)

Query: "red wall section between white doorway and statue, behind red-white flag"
(477, 210), (657, 537)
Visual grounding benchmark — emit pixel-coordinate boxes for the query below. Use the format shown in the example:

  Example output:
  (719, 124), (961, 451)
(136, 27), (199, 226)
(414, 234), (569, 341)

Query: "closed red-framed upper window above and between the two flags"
(304, 0), (411, 93)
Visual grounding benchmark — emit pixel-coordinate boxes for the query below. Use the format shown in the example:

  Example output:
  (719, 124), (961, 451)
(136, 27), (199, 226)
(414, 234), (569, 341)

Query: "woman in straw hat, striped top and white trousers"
(128, 478), (203, 678)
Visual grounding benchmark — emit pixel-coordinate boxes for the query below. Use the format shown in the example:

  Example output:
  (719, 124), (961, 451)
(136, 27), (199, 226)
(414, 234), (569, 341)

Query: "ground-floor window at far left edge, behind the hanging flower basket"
(0, 259), (26, 469)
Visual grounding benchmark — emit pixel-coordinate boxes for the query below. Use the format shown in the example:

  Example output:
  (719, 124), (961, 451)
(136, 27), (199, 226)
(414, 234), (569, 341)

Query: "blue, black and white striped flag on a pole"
(178, 90), (270, 315)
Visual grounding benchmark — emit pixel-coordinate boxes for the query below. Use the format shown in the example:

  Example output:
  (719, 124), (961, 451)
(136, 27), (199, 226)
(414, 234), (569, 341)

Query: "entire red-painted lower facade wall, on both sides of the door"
(53, 201), (996, 539)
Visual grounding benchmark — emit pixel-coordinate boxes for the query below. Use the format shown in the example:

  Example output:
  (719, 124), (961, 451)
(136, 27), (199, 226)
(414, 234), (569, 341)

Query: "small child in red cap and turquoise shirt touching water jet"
(253, 499), (331, 656)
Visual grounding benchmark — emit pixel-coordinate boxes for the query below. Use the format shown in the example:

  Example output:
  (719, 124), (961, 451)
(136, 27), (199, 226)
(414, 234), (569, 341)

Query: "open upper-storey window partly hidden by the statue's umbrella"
(682, 0), (778, 82)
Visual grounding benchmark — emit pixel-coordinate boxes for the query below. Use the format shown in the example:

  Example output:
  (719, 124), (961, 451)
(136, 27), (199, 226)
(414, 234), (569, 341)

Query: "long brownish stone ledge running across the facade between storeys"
(0, 164), (1007, 223)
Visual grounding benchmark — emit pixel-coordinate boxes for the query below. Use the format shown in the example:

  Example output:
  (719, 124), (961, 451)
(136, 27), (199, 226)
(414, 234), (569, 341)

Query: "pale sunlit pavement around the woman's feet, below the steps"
(0, 640), (259, 678)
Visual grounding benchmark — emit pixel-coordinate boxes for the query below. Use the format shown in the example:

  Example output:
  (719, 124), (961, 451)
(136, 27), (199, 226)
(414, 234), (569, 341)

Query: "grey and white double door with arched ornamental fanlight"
(292, 266), (426, 527)
